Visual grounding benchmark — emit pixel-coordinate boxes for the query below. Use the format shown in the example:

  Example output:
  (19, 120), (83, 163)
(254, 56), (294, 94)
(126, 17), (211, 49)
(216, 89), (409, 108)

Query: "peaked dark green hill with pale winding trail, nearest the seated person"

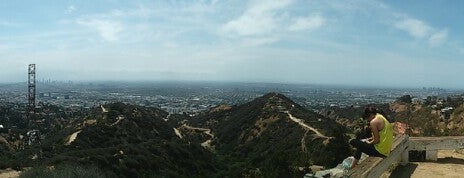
(179, 93), (350, 177)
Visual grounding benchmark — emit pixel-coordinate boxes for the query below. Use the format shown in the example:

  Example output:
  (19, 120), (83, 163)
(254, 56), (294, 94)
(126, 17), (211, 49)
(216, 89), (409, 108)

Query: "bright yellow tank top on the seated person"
(374, 114), (393, 156)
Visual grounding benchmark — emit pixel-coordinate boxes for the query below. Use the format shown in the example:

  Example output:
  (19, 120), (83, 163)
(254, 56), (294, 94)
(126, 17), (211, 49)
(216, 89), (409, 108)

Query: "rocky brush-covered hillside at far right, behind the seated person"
(321, 95), (464, 136)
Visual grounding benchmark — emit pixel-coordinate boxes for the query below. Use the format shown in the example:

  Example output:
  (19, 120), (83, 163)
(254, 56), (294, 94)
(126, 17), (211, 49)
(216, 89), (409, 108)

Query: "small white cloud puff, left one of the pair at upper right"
(394, 18), (432, 38)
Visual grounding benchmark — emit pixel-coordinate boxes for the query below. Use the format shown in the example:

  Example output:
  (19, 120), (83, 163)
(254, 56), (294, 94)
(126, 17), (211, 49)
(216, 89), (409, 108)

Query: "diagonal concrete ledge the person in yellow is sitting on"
(348, 135), (409, 178)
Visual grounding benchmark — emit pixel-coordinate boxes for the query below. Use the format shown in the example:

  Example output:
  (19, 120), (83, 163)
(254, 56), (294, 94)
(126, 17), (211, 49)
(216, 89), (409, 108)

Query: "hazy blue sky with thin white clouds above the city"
(0, 0), (464, 89)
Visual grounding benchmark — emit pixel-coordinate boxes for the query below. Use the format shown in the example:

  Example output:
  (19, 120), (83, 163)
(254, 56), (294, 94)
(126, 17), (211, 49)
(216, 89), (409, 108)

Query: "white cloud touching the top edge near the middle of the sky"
(222, 0), (291, 36)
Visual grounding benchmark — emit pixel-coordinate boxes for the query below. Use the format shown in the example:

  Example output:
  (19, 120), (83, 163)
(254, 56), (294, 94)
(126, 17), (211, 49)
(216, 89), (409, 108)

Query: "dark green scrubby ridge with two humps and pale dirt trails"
(0, 93), (351, 177)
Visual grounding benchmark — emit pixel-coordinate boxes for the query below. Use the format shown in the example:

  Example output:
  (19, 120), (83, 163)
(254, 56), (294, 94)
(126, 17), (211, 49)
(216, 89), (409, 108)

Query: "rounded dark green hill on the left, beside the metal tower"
(8, 103), (221, 177)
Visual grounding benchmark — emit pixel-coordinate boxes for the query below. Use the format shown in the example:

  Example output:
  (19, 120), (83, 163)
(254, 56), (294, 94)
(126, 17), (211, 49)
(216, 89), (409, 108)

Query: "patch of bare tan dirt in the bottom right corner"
(387, 150), (464, 178)
